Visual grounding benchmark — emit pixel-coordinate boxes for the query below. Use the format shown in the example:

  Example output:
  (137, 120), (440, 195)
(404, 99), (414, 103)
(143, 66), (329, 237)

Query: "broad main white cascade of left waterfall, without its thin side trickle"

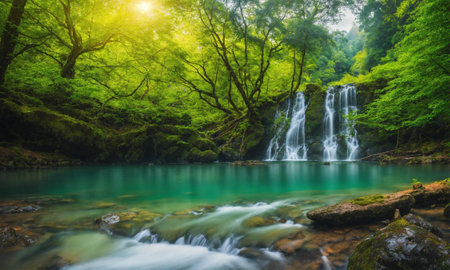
(284, 92), (308, 160)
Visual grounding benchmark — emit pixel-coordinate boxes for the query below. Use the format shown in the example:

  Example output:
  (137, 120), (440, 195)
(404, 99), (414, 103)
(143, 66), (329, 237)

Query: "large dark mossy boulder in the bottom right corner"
(348, 218), (450, 270)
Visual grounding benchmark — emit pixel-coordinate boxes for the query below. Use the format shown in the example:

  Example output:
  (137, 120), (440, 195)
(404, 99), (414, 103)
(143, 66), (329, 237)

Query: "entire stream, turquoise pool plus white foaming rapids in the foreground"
(0, 162), (448, 270)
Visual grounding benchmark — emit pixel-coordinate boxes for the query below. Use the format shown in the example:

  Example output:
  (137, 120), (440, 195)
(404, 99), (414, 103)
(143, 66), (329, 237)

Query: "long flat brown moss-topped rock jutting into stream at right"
(307, 193), (414, 225)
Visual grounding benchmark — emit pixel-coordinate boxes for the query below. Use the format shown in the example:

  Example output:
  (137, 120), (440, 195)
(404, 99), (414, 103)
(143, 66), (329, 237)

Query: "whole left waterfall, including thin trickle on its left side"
(266, 92), (308, 161)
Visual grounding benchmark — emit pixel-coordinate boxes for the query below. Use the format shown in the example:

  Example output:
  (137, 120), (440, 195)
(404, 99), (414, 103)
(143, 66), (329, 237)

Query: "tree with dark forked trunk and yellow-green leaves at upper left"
(32, 0), (120, 79)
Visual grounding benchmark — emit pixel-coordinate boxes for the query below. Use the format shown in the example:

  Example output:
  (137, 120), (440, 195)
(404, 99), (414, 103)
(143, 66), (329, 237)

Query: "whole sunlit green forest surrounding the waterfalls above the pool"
(0, 0), (450, 167)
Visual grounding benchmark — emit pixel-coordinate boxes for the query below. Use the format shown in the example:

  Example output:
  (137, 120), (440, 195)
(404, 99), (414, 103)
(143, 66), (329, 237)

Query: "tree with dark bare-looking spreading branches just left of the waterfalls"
(174, 0), (286, 118)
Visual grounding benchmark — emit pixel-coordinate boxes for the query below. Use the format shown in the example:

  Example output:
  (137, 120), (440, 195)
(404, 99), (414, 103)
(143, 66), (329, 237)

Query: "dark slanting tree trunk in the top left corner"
(0, 0), (27, 85)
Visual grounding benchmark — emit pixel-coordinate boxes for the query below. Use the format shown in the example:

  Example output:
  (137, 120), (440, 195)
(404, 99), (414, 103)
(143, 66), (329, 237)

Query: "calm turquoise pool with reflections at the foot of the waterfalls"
(0, 162), (449, 208)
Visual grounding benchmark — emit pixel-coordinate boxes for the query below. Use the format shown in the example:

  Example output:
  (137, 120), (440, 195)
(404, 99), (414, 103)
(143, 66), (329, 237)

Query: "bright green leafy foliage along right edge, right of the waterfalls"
(361, 0), (450, 134)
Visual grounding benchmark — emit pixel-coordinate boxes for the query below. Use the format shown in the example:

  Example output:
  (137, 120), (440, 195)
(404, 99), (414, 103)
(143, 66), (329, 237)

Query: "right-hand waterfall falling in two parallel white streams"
(323, 85), (359, 161)
